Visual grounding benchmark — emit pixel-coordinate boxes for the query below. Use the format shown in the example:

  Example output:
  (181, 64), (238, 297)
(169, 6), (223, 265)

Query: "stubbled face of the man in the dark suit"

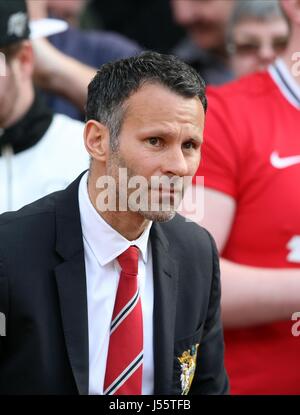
(107, 84), (204, 221)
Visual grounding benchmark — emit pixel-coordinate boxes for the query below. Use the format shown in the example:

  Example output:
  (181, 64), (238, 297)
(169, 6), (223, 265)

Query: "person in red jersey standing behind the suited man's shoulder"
(186, 0), (300, 394)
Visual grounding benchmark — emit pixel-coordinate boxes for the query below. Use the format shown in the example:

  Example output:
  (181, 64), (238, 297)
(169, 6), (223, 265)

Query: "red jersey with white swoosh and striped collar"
(197, 60), (300, 394)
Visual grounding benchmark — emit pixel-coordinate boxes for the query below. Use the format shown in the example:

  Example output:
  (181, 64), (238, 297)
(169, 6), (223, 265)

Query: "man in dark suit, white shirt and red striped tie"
(0, 52), (228, 394)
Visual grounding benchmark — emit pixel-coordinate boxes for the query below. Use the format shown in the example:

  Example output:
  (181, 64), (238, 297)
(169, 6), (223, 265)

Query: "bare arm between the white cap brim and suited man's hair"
(32, 39), (96, 112)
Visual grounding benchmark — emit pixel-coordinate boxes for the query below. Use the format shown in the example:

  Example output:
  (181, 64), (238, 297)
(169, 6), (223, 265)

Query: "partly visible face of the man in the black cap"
(0, 61), (18, 128)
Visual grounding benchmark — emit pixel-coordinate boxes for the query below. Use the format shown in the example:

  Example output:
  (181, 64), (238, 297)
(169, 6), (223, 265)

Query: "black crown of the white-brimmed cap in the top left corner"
(0, 0), (30, 47)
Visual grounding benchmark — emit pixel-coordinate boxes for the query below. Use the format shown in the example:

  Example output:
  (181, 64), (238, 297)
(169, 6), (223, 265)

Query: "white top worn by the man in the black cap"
(0, 114), (89, 213)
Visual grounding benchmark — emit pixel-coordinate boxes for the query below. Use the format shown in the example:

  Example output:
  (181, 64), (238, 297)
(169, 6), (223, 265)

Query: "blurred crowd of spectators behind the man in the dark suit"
(0, 0), (300, 394)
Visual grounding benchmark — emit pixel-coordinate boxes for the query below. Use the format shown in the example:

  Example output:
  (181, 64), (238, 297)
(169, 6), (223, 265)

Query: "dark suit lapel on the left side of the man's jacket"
(55, 176), (89, 394)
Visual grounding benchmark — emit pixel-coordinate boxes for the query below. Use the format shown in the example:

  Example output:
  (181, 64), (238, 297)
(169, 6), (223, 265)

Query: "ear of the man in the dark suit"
(84, 120), (110, 163)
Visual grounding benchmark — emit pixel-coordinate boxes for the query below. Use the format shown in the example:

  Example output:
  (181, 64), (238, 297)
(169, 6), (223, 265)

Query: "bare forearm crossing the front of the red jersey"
(221, 259), (300, 327)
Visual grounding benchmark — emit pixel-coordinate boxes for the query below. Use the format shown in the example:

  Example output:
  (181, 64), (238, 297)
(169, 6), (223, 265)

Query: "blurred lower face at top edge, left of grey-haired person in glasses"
(171, 0), (236, 50)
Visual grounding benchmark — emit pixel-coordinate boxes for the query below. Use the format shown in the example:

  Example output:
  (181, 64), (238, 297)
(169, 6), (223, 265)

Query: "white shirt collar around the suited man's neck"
(78, 172), (152, 266)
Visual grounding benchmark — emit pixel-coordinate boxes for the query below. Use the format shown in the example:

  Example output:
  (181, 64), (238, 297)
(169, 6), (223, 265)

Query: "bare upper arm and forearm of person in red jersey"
(182, 189), (300, 327)
